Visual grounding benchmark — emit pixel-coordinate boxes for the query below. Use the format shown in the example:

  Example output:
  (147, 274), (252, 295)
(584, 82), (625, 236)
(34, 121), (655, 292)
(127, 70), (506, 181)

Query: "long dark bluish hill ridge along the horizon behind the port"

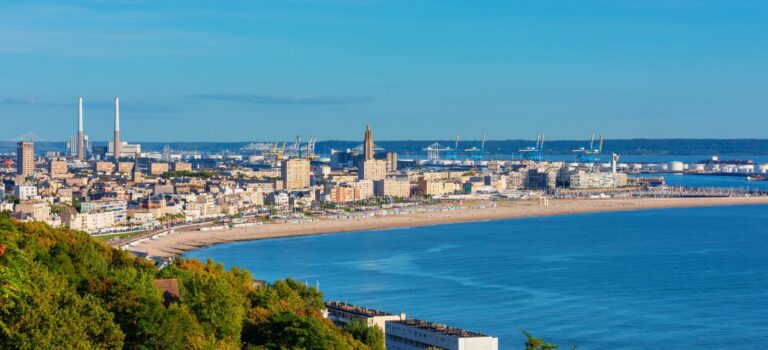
(0, 139), (768, 155)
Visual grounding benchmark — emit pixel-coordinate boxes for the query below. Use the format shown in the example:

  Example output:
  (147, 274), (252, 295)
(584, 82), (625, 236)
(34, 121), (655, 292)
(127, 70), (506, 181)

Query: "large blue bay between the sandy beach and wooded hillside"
(188, 206), (768, 349)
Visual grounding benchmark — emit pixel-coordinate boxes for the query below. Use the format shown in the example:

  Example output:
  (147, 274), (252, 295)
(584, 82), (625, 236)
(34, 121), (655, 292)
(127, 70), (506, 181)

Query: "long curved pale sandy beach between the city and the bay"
(131, 197), (768, 256)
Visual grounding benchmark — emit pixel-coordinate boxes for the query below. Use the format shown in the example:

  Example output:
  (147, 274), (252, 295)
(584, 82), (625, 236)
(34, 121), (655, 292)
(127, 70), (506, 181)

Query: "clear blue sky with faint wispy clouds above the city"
(0, 0), (768, 141)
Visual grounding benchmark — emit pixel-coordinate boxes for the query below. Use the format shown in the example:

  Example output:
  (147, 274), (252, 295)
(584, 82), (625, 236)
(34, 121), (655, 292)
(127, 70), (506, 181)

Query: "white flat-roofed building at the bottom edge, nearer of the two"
(385, 319), (499, 350)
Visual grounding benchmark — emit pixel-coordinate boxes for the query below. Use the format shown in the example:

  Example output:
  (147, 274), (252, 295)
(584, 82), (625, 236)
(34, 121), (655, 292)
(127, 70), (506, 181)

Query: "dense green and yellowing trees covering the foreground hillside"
(0, 213), (382, 349)
